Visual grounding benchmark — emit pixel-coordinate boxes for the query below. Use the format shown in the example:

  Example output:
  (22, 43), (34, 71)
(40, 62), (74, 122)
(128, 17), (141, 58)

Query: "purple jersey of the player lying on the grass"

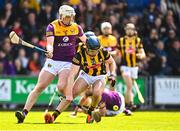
(101, 91), (122, 111)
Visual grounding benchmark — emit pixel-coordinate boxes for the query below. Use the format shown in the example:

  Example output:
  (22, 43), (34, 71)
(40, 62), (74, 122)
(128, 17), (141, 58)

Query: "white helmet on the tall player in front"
(59, 5), (76, 19)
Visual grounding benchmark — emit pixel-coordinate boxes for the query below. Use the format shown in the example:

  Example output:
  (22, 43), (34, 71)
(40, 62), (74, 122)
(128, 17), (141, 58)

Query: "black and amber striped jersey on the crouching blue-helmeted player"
(72, 47), (110, 76)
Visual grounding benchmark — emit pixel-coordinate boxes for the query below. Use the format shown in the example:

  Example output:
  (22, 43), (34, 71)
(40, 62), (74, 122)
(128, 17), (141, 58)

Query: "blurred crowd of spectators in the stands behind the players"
(0, 0), (180, 75)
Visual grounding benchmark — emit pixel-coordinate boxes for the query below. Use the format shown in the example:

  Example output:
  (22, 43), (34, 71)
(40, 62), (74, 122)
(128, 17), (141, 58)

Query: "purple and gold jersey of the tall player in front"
(46, 20), (84, 62)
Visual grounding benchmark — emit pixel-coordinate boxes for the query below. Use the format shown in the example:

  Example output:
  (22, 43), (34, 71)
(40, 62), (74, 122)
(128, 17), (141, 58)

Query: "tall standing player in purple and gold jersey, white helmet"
(15, 5), (86, 123)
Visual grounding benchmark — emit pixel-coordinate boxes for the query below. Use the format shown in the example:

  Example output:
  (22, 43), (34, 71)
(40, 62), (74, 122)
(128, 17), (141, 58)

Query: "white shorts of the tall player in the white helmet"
(43, 59), (72, 76)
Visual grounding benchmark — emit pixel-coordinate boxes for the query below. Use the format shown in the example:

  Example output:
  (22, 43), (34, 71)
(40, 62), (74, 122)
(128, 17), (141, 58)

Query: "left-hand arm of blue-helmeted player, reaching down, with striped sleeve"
(66, 53), (80, 101)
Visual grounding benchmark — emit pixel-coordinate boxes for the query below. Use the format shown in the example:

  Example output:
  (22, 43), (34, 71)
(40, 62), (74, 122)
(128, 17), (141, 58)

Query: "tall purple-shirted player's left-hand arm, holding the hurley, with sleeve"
(46, 24), (54, 58)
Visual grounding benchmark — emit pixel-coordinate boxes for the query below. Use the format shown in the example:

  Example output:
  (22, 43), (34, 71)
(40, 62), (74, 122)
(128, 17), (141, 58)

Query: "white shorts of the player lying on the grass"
(106, 93), (125, 116)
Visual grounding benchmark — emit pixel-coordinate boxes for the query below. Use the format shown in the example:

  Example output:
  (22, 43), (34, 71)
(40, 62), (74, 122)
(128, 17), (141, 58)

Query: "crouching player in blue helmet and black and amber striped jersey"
(45, 36), (116, 123)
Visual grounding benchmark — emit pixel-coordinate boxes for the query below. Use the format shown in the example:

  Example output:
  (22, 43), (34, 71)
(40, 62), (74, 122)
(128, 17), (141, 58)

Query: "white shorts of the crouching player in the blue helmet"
(78, 70), (106, 85)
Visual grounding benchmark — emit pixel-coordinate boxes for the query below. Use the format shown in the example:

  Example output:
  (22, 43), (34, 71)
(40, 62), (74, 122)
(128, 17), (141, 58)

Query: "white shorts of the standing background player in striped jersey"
(120, 66), (138, 79)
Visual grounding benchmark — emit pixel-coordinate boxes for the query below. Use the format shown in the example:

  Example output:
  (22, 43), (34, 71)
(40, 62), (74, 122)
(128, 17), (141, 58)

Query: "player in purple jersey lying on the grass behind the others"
(71, 89), (132, 116)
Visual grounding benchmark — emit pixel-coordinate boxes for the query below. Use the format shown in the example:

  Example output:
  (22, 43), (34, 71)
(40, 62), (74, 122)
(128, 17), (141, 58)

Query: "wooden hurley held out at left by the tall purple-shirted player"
(9, 31), (48, 53)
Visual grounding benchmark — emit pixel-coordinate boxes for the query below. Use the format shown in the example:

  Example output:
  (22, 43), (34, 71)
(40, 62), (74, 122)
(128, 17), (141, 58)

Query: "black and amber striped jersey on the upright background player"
(118, 36), (143, 67)
